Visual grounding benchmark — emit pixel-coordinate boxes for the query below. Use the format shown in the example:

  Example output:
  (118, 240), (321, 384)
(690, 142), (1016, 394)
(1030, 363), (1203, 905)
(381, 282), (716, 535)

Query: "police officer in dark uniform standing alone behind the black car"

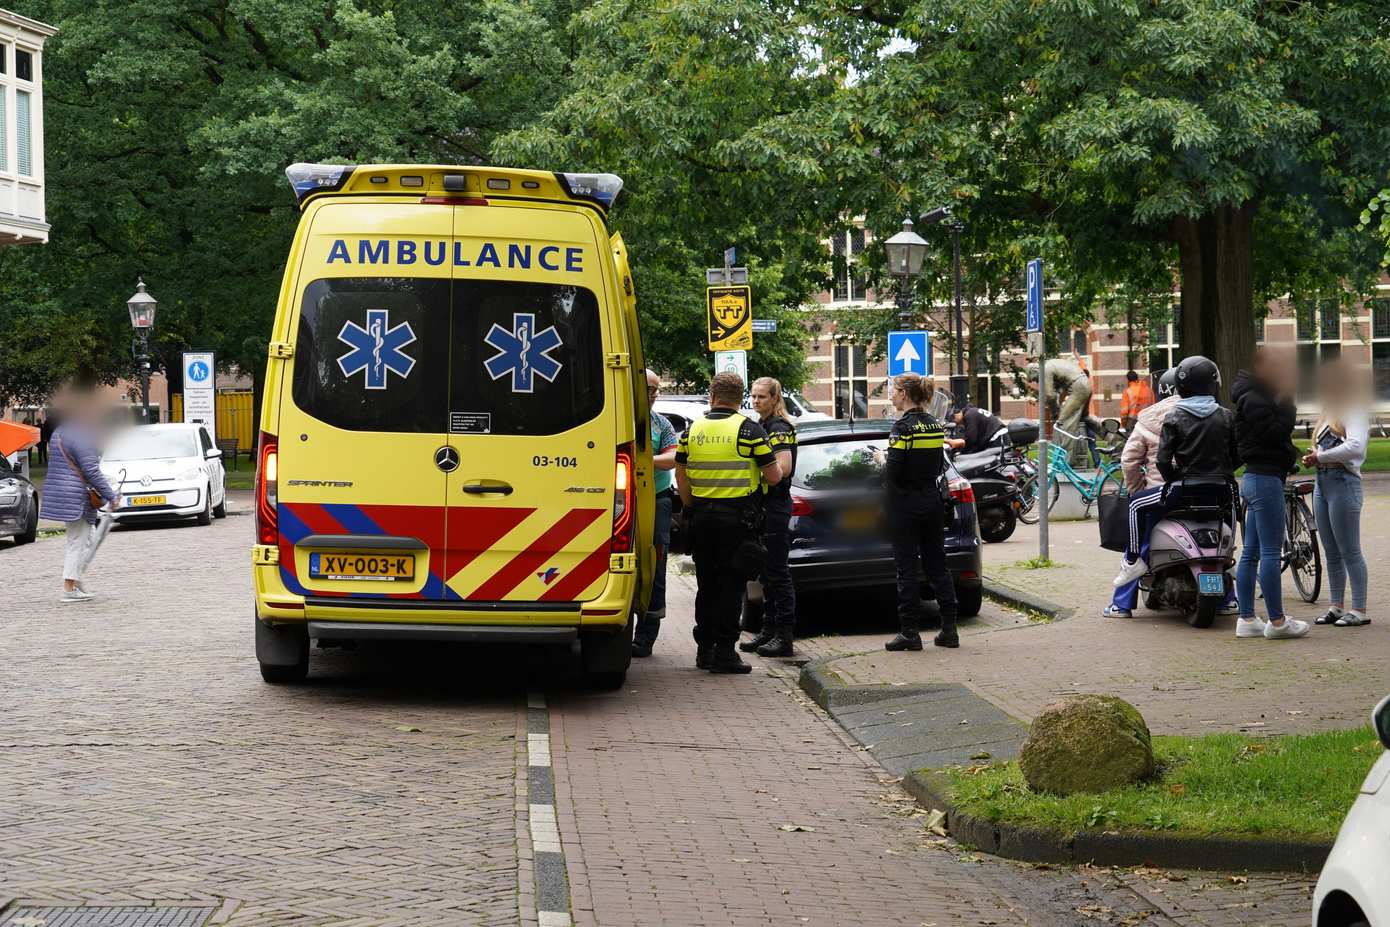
(883, 374), (960, 650)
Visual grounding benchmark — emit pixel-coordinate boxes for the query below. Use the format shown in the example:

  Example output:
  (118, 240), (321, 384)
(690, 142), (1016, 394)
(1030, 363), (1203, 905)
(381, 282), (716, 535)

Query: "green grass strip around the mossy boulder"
(941, 725), (1383, 839)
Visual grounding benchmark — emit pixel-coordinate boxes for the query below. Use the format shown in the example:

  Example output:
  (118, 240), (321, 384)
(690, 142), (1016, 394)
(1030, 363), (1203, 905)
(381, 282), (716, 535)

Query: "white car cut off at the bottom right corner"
(1312, 696), (1390, 927)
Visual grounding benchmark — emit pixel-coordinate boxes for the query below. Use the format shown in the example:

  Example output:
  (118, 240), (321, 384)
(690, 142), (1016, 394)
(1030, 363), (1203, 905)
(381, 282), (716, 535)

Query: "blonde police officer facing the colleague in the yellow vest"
(738, 377), (796, 656)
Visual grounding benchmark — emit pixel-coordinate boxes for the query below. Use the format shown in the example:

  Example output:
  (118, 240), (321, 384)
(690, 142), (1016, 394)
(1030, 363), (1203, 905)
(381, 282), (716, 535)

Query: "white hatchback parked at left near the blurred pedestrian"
(101, 424), (227, 525)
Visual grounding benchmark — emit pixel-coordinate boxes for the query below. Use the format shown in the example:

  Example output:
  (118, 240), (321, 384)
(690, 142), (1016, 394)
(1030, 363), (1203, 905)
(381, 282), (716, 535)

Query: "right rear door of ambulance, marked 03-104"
(448, 200), (617, 608)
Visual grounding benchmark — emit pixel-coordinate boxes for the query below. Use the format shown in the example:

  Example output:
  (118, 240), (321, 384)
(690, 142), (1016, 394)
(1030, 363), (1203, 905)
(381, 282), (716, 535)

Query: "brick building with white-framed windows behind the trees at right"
(802, 228), (1390, 418)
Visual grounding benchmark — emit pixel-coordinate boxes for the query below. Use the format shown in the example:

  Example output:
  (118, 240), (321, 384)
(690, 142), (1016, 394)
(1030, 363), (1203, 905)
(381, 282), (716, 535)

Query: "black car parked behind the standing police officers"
(748, 418), (983, 621)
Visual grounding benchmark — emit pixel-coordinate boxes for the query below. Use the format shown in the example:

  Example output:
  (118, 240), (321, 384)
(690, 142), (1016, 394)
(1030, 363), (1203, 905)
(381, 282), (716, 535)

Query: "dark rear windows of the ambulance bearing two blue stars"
(293, 278), (606, 435)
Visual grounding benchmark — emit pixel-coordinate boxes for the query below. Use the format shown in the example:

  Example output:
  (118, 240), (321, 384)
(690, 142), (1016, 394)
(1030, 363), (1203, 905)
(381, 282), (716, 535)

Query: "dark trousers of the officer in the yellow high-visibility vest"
(691, 502), (748, 649)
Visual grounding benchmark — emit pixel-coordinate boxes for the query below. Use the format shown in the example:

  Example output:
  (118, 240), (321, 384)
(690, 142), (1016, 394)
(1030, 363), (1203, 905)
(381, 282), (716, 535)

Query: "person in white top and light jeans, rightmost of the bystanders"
(1302, 360), (1371, 628)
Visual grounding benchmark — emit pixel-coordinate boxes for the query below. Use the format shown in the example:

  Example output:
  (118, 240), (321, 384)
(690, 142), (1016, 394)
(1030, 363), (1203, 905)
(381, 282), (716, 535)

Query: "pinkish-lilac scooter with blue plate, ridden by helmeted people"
(1138, 479), (1236, 628)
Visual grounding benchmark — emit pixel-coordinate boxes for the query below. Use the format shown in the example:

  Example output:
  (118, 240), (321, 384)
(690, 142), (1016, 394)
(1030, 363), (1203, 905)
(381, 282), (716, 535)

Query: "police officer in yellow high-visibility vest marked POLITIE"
(676, 372), (783, 673)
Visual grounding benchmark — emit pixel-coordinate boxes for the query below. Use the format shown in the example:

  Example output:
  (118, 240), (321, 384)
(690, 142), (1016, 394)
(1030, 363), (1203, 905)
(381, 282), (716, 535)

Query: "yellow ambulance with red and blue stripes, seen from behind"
(252, 164), (653, 688)
